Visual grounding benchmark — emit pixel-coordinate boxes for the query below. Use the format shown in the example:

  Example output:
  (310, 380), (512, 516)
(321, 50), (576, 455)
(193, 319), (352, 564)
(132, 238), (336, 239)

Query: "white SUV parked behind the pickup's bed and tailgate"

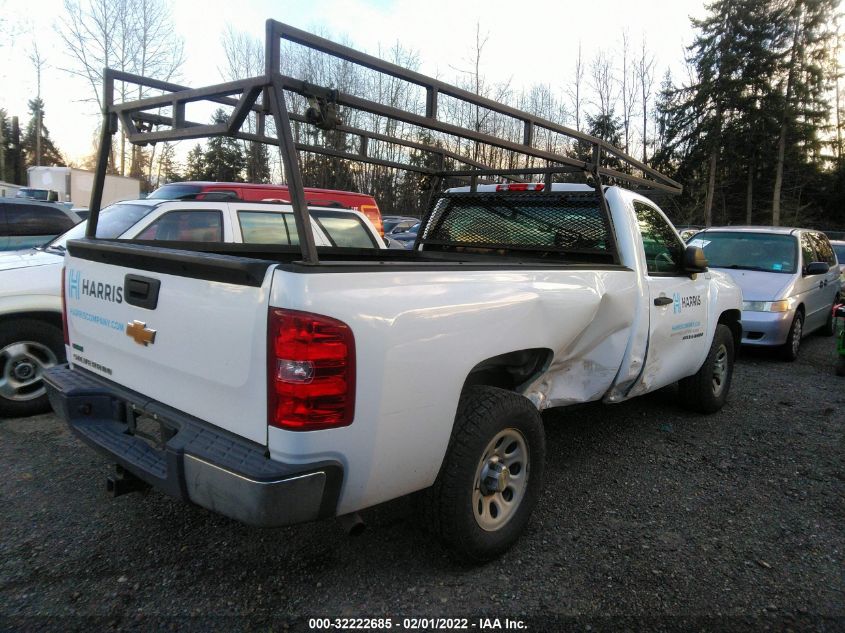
(0, 199), (385, 417)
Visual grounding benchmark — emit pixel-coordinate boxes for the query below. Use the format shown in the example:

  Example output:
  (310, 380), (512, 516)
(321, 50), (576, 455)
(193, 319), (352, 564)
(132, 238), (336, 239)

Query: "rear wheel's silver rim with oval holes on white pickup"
(472, 428), (529, 532)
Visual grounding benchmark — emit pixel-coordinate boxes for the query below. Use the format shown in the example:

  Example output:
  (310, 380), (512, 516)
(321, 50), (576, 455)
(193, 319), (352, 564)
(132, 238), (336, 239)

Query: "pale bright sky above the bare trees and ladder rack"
(0, 0), (705, 161)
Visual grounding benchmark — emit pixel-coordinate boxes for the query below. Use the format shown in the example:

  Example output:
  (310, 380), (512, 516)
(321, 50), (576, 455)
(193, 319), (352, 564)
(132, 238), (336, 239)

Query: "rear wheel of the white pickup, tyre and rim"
(424, 386), (546, 562)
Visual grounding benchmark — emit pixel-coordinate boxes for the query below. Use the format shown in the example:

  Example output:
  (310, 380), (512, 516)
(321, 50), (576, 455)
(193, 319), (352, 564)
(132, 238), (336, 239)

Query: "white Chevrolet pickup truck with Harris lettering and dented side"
(46, 23), (742, 561)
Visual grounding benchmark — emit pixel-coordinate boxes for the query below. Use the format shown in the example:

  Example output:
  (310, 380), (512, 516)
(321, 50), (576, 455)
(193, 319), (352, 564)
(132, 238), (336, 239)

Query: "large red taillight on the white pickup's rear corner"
(267, 308), (355, 431)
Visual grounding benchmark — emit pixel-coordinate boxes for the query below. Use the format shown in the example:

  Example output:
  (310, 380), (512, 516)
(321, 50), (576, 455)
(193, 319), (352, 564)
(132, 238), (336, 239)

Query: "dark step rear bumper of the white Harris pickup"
(44, 365), (343, 527)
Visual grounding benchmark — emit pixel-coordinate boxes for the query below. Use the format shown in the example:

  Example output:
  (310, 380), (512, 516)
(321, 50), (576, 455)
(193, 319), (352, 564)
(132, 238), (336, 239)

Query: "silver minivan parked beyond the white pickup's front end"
(690, 226), (841, 360)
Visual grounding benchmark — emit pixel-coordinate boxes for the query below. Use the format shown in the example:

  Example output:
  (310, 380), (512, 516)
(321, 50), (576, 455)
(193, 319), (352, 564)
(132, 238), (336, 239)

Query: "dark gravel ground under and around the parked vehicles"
(0, 336), (845, 631)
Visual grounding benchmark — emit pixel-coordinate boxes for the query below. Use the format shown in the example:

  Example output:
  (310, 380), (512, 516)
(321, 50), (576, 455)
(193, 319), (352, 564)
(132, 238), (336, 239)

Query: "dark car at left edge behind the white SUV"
(0, 198), (82, 251)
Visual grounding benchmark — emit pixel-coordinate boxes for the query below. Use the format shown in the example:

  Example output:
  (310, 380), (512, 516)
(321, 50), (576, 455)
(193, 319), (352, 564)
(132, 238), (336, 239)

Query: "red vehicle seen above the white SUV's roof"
(147, 181), (384, 235)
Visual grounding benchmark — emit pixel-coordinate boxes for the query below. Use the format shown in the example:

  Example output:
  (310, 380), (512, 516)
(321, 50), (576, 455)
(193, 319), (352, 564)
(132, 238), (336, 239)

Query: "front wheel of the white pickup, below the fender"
(678, 323), (734, 413)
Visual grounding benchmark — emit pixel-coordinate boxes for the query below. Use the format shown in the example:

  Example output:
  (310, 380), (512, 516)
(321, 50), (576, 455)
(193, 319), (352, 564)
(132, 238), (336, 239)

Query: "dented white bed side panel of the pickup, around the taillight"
(269, 268), (639, 514)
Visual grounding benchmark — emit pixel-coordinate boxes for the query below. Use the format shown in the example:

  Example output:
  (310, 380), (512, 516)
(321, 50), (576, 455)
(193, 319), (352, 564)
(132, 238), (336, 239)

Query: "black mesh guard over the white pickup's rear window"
(418, 191), (619, 264)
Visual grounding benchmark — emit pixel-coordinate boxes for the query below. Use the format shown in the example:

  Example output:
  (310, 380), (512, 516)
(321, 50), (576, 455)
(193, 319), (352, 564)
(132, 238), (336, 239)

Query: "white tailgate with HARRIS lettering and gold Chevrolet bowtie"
(64, 240), (276, 444)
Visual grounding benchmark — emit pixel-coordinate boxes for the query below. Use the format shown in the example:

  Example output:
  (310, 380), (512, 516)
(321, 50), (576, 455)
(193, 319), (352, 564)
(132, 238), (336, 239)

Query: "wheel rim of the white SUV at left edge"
(0, 341), (59, 402)
